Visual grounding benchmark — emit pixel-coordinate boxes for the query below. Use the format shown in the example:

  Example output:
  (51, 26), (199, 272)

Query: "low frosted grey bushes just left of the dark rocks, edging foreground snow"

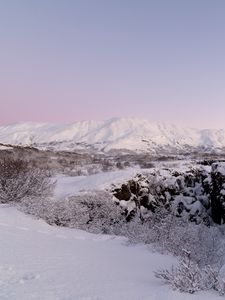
(20, 191), (125, 233)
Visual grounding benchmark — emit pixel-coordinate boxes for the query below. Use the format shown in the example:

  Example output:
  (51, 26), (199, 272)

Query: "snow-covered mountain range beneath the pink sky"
(0, 118), (225, 153)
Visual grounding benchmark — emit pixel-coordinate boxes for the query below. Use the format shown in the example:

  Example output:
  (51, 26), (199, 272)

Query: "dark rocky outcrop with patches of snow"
(112, 163), (225, 225)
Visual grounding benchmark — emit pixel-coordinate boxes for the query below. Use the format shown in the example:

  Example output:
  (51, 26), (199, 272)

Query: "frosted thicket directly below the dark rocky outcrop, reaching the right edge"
(116, 205), (225, 268)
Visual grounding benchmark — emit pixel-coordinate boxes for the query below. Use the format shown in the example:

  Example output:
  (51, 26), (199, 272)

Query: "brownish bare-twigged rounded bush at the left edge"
(0, 158), (54, 203)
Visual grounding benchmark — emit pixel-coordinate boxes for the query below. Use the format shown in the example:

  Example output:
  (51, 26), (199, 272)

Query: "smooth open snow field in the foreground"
(0, 205), (221, 300)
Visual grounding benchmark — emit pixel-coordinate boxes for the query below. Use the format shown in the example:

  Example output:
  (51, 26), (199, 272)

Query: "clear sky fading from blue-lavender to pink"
(0, 0), (225, 129)
